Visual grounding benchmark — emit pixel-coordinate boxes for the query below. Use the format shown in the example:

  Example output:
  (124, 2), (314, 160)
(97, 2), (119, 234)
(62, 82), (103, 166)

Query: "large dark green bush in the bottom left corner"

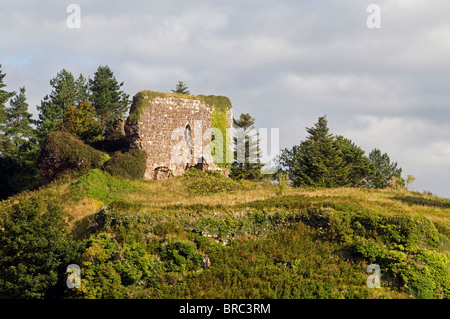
(0, 195), (77, 298)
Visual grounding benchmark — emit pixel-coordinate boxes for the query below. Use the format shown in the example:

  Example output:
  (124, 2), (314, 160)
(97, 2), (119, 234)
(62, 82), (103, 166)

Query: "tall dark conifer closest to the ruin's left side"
(89, 65), (131, 131)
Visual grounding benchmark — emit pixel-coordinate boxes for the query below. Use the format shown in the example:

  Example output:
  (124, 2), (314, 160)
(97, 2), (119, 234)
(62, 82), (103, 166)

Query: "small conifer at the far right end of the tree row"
(369, 148), (402, 188)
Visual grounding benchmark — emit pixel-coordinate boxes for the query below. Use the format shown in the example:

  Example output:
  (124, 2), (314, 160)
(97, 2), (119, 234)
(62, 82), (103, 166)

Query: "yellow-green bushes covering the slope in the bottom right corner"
(298, 211), (450, 299)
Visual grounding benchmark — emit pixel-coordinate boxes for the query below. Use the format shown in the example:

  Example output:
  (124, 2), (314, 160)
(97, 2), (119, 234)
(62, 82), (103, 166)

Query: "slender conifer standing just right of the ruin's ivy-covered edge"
(230, 113), (264, 180)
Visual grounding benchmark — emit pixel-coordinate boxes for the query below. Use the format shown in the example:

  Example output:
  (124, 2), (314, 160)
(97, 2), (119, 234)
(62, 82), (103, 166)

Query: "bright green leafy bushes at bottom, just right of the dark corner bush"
(68, 232), (204, 299)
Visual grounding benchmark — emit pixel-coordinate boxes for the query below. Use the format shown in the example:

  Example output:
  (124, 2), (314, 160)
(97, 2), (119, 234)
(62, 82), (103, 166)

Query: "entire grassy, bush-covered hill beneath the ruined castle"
(0, 169), (450, 298)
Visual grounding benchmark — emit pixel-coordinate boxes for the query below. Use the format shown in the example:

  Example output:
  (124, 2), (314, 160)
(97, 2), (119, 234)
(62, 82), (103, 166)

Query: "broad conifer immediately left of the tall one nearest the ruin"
(37, 69), (87, 141)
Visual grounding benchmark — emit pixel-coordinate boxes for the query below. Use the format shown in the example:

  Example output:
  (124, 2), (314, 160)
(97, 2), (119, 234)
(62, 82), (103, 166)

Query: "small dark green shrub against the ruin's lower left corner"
(103, 148), (147, 179)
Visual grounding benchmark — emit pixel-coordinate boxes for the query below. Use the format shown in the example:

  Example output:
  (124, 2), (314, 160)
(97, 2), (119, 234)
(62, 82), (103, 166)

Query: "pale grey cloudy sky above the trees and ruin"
(0, 0), (450, 198)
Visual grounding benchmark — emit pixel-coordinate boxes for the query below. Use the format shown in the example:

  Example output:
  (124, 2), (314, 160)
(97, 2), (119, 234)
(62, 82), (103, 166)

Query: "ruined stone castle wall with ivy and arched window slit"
(125, 91), (233, 179)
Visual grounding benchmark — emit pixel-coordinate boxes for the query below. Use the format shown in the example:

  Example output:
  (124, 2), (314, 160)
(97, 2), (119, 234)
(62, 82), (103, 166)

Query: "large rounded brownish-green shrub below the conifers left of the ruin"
(38, 131), (109, 182)
